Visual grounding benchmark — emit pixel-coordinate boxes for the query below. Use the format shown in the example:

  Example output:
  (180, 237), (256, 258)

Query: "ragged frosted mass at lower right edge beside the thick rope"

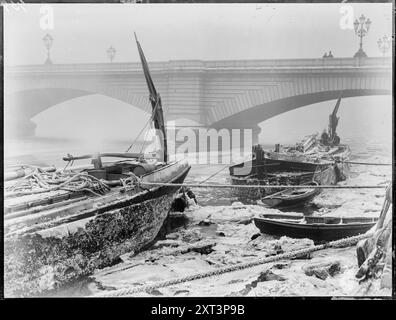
(356, 185), (393, 289)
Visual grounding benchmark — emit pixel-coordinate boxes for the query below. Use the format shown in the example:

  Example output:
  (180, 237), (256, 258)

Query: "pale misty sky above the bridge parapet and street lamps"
(4, 3), (392, 65)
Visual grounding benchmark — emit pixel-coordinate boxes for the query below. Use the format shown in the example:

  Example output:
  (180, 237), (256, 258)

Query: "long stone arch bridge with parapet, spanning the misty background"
(4, 58), (392, 137)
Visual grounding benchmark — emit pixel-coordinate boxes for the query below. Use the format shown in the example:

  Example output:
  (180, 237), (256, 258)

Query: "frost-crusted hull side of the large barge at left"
(4, 160), (190, 297)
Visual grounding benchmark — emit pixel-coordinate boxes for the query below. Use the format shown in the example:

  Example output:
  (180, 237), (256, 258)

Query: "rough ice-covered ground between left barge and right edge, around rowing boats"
(4, 136), (392, 297)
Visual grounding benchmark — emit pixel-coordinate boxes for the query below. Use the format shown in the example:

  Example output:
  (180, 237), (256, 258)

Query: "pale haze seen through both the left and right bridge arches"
(33, 95), (392, 144)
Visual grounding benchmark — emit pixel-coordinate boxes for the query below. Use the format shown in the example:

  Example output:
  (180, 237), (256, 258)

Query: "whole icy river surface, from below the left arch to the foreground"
(4, 132), (392, 296)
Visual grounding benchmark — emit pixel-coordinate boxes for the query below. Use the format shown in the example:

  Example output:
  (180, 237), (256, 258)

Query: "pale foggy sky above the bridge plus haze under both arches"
(4, 4), (392, 147)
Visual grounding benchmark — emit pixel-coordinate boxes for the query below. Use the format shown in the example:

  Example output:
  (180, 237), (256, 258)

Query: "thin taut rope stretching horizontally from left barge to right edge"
(141, 181), (387, 189)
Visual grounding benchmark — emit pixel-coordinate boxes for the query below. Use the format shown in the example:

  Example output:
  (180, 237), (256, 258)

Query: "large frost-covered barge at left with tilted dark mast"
(4, 33), (190, 297)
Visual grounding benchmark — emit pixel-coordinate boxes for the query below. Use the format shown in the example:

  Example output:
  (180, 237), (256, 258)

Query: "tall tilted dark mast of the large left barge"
(134, 33), (168, 163)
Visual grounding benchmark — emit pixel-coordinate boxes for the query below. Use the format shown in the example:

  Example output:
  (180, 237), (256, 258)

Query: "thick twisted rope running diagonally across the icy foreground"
(94, 233), (372, 297)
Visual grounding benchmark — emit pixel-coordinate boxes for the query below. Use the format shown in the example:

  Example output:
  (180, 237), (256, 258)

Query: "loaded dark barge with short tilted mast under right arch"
(229, 98), (350, 202)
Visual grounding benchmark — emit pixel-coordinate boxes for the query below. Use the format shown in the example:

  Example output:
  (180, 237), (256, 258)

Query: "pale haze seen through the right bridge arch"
(260, 96), (392, 146)
